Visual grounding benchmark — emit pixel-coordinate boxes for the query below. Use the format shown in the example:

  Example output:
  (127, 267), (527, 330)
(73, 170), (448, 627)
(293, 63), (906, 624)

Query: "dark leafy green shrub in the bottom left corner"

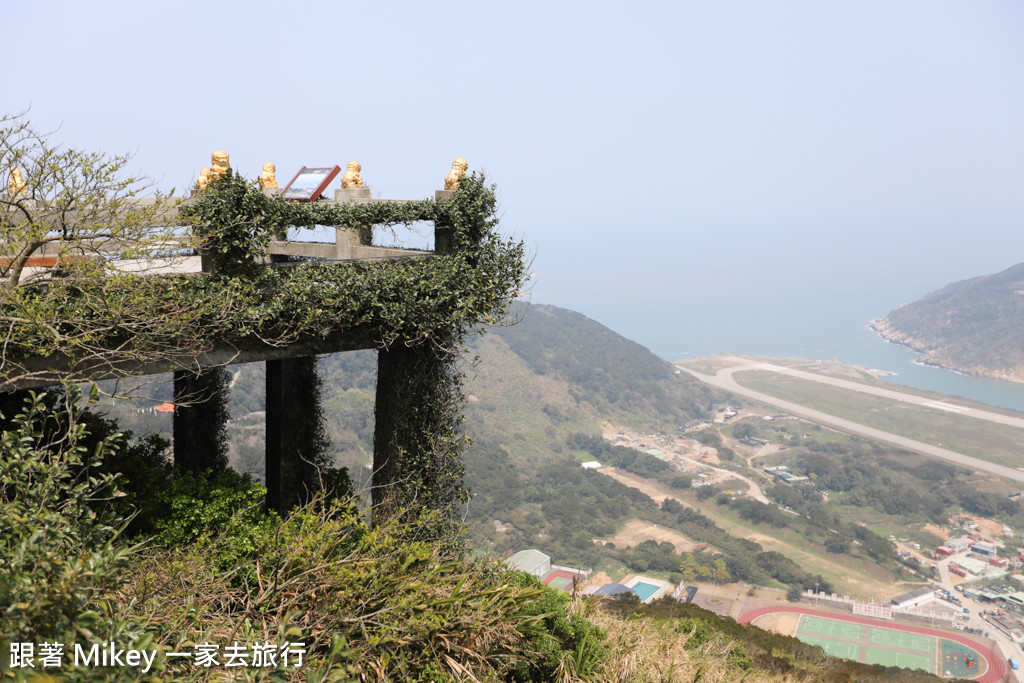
(0, 387), (161, 681)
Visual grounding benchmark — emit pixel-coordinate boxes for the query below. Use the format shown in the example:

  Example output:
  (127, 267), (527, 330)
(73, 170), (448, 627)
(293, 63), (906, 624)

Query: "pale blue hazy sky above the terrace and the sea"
(3, 0), (1024, 348)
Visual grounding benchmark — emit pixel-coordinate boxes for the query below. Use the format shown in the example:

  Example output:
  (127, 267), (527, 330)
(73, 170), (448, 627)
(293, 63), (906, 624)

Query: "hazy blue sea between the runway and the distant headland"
(581, 296), (1024, 412)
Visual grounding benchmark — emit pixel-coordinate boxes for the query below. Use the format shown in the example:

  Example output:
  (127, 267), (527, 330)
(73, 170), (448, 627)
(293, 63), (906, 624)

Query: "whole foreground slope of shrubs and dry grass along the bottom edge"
(0, 393), (950, 682)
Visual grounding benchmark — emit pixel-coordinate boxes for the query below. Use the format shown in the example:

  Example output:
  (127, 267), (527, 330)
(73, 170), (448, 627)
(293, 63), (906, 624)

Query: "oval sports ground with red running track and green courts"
(738, 605), (1006, 683)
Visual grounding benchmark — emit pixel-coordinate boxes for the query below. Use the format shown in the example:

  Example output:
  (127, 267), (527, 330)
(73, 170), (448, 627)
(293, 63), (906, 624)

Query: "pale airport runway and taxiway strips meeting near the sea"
(677, 358), (1024, 482)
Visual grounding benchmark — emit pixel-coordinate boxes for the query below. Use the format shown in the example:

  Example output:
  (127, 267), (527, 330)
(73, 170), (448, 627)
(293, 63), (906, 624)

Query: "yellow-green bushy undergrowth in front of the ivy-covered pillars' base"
(118, 500), (604, 681)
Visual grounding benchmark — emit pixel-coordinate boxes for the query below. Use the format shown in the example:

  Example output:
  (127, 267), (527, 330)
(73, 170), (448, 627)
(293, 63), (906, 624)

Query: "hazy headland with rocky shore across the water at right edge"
(872, 263), (1024, 382)
